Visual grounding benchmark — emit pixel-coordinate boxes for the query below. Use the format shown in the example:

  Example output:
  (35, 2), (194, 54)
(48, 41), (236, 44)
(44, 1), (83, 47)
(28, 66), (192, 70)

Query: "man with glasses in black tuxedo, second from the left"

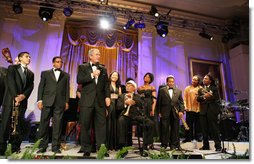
(37, 56), (70, 153)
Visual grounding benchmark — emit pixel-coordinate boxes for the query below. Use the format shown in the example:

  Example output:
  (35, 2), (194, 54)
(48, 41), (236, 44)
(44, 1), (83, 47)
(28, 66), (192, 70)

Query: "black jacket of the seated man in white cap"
(117, 93), (143, 119)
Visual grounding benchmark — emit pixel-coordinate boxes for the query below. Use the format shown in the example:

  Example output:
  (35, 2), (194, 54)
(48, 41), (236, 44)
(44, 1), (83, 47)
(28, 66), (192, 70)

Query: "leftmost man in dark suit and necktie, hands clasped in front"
(0, 52), (34, 155)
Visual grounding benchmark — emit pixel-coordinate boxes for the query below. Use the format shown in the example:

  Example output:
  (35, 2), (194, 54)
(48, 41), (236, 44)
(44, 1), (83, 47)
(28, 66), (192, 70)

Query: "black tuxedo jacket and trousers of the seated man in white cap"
(117, 93), (154, 148)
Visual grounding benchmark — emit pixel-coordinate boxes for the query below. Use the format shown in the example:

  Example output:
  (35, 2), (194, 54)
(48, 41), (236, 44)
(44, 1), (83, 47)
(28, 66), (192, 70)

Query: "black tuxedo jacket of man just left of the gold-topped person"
(157, 86), (184, 118)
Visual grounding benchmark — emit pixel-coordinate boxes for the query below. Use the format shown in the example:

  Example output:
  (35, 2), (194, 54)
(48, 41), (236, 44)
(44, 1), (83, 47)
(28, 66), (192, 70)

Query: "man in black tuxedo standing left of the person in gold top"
(157, 75), (184, 150)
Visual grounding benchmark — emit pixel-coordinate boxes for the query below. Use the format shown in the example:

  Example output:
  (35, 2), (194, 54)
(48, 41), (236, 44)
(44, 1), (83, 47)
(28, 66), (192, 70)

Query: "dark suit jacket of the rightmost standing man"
(197, 85), (221, 115)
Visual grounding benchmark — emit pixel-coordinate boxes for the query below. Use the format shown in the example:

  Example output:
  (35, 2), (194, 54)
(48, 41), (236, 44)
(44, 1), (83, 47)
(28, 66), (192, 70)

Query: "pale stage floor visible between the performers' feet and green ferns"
(0, 140), (249, 160)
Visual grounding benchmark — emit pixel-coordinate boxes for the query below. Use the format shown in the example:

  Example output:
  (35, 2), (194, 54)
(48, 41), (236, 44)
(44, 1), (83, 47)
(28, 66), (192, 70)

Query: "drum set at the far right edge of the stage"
(219, 99), (249, 142)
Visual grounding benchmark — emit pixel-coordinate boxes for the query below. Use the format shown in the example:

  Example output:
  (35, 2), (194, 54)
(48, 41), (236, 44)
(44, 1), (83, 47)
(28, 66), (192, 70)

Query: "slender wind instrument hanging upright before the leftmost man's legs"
(11, 101), (19, 136)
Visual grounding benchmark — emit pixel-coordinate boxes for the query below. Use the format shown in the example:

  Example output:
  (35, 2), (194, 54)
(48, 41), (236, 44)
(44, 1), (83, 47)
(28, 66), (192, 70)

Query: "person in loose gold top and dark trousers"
(183, 75), (202, 142)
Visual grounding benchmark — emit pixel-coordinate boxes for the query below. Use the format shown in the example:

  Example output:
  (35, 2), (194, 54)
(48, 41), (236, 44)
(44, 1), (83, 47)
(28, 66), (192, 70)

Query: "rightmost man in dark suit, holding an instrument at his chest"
(197, 74), (221, 151)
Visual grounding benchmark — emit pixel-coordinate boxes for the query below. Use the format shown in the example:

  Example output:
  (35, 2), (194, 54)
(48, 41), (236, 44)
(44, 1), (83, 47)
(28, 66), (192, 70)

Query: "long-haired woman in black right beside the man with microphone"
(107, 71), (122, 150)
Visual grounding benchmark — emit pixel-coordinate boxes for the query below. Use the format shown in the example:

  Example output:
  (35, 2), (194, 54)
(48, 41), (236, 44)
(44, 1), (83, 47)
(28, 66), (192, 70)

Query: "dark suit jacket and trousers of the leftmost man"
(0, 65), (34, 154)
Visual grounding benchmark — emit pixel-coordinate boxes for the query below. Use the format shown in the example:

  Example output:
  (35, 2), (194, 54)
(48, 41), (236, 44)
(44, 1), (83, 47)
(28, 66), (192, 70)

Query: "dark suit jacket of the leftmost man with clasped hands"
(3, 64), (34, 109)
